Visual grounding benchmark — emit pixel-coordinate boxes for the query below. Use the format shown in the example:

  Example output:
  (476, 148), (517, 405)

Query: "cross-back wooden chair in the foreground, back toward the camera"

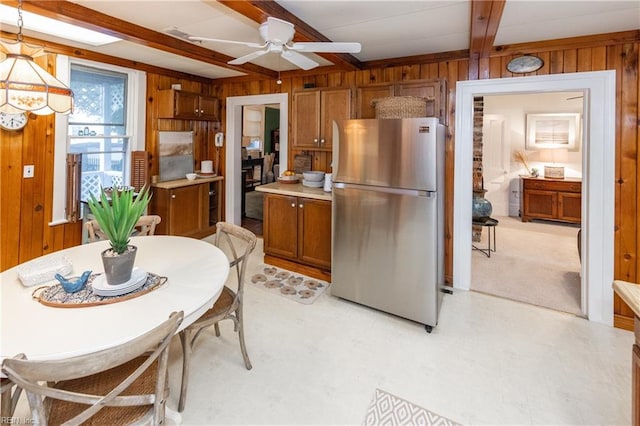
(2, 312), (183, 425)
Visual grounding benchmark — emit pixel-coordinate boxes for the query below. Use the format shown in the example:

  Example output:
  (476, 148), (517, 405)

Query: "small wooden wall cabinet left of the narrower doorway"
(156, 89), (220, 121)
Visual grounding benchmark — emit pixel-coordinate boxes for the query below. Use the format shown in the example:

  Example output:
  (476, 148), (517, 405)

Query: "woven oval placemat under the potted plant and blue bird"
(33, 272), (167, 308)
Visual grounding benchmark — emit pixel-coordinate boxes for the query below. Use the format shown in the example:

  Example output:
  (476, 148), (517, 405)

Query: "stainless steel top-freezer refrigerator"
(331, 118), (445, 332)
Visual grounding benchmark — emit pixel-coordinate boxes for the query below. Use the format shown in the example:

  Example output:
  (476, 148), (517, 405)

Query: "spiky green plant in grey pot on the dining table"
(88, 186), (151, 285)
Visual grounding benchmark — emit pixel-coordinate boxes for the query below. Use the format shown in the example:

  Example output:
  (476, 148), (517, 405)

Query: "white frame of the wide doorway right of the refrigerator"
(453, 71), (616, 326)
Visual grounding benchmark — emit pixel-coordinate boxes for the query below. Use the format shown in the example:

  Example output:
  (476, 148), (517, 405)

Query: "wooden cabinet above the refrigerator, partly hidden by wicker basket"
(356, 79), (448, 125)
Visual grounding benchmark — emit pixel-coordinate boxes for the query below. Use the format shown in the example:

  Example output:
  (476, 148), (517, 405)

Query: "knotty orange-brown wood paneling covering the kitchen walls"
(0, 39), (640, 328)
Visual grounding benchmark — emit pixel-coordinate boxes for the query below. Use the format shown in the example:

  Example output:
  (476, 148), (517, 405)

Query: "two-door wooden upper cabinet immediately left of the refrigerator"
(293, 89), (351, 151)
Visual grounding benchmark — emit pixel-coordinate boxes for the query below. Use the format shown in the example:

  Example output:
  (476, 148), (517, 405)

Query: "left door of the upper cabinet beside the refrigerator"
(293, 90), (320, 149)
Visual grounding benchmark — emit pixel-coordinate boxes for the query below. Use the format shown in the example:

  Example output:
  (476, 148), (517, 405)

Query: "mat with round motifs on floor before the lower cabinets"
(249, 264), (330, 305)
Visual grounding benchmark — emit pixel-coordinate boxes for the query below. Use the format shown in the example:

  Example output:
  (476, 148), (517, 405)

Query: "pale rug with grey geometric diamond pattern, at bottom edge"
(363, 389), (459, 426)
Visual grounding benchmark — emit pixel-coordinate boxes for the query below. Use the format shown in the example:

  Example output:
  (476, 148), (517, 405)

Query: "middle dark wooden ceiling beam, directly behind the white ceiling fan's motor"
(217, 0), (362, 71)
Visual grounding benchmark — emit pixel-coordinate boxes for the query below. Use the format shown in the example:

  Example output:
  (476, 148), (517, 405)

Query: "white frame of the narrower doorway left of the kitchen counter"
(225, 93), (289, 225)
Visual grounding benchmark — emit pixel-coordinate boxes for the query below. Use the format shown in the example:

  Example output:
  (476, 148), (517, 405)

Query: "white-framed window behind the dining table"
(50, 55), (146, 225)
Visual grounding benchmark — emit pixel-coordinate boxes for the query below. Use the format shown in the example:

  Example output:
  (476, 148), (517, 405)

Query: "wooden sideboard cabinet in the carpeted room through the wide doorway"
(520, 177), (582, 224)
